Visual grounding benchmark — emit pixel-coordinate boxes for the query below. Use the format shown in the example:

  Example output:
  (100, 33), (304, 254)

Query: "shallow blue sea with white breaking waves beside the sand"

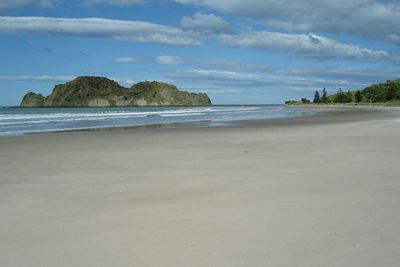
(0, 105), (311, 136)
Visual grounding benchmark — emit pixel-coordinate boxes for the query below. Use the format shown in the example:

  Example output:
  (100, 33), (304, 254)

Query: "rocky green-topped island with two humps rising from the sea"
(21, 76), (211, 107)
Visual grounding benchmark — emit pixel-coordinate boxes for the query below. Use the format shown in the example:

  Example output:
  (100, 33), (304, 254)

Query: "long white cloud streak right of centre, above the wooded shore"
(220, 31), (390, 60)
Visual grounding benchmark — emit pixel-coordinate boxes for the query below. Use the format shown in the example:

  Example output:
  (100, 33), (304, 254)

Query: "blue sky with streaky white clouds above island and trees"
(0, 0), (400, 106)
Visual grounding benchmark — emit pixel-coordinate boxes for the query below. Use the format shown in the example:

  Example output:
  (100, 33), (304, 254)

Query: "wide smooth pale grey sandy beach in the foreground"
(0, 107), (400, 267)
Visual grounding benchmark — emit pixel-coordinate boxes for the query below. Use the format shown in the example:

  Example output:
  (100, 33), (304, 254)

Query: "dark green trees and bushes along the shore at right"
(285, 80), (400, 105)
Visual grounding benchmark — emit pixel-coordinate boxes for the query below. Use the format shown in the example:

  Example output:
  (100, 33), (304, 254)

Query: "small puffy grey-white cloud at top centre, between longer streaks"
(181, 13), (233, 33)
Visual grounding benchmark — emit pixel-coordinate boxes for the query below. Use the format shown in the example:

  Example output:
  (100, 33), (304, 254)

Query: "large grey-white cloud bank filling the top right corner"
(175, 0), (400, 44)
